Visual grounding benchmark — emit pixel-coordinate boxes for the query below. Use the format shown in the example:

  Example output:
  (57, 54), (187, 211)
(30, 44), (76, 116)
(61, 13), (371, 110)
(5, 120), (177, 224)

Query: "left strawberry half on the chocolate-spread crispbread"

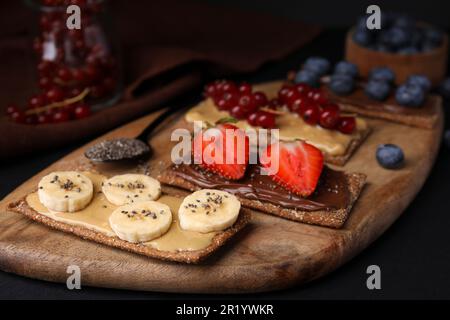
(193, 123), (249, 180)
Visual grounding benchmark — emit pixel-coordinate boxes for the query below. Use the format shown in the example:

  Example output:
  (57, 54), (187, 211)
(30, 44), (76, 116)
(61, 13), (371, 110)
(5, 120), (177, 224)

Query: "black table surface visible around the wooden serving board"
(0, 30), (450, 299)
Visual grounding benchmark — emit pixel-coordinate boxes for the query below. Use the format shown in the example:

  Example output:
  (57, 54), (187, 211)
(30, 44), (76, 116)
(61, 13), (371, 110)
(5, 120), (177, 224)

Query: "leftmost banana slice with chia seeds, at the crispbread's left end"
(38, 171), (94, 212)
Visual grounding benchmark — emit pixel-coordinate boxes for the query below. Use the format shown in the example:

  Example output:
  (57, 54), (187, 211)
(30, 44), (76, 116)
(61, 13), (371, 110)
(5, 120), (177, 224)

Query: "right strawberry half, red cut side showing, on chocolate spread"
(261, 141), (323, 197)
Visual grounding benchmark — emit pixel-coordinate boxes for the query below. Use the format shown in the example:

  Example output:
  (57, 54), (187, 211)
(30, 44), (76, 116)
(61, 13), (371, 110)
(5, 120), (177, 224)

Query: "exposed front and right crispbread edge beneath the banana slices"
(8, 198), (251, 263)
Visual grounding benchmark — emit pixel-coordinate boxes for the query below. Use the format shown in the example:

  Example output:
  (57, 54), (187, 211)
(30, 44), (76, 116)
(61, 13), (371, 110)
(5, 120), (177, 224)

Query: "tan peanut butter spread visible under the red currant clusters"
(185, 83), (367, 156)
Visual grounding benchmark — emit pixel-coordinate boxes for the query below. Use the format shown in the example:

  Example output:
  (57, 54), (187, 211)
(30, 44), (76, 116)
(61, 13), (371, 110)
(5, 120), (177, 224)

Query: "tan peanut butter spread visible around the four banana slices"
(26, 172), (216, 251)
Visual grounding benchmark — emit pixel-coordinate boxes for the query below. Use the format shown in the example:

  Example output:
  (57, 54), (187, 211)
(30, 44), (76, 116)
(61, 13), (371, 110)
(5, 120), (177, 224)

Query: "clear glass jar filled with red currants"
(26, 0), (122, 111)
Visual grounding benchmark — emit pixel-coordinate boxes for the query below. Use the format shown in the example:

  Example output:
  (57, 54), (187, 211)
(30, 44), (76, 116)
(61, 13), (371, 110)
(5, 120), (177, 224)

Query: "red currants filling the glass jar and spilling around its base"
(6, 0), (118, 124)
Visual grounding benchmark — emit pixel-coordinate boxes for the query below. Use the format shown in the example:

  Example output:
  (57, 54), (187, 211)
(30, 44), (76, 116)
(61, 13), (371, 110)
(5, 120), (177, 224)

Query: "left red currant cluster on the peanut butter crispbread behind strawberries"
(204, 80), (276, 128)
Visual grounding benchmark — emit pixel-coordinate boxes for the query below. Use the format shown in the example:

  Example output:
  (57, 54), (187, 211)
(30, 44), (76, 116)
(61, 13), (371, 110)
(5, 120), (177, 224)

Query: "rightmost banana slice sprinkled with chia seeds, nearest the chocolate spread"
(178, 189), (241, 233)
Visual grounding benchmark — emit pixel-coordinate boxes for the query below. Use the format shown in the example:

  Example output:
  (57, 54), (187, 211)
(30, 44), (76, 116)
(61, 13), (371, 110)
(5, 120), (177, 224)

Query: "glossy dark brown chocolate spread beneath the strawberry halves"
(169, 165), (350, 211)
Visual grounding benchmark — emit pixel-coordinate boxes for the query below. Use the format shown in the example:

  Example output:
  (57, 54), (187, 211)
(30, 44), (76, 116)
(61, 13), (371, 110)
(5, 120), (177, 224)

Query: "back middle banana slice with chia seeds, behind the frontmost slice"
(102, 174), (161, 206)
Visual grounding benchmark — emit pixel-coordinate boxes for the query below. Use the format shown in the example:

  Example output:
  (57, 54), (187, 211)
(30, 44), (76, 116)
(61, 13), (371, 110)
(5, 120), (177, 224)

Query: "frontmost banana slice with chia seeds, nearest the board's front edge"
(109, 201), (172, 243)
